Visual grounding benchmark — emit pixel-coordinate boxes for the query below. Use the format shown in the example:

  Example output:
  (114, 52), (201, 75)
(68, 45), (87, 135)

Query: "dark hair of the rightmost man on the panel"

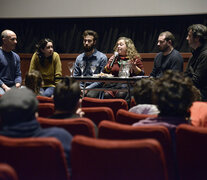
(188, 24), (207, 44)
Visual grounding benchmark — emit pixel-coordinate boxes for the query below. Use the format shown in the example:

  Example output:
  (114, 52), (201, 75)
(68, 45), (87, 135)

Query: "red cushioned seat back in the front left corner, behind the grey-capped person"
(0, 136), (69, 180)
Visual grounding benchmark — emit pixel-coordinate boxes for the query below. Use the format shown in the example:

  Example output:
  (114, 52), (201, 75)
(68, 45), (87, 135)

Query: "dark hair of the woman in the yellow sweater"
(36, 38), (53, 66)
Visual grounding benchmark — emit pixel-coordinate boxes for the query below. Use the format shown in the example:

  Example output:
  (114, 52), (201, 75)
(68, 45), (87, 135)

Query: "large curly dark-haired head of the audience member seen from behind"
(153, 70), (195, 117)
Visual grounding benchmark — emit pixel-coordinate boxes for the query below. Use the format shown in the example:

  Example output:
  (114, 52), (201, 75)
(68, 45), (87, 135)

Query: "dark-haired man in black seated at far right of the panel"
(185, 24), (207, 101)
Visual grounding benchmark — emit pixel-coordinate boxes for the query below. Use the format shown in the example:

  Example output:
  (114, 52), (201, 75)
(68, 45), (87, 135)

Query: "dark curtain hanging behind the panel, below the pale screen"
(0, 14), (207, 53)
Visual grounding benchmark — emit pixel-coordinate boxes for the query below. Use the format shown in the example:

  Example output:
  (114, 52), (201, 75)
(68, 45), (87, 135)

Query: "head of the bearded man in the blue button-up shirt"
(82, 30), (98, 52)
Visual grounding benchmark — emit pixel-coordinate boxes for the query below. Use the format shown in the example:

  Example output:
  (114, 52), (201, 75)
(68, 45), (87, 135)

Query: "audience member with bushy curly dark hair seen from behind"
(134, 70), (196, 131)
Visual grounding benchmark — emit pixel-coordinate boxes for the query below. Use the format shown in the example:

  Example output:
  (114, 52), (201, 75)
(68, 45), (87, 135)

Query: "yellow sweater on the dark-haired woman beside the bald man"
(29, 52), (62, 87)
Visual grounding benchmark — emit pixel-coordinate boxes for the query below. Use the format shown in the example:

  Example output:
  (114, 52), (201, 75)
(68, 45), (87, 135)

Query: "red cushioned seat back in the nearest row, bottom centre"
(71, 136), (167, 180)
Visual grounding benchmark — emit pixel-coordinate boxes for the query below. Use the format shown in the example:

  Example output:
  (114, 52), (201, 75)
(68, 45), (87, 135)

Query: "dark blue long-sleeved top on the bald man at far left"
(0, 48), (22, 87)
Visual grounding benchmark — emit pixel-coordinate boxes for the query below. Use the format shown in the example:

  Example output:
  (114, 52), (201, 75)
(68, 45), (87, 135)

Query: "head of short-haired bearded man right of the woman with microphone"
(157, 31), (175, 52)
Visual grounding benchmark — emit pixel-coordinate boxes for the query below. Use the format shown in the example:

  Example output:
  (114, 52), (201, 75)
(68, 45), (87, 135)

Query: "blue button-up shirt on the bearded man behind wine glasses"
(73, 49), (108, 89)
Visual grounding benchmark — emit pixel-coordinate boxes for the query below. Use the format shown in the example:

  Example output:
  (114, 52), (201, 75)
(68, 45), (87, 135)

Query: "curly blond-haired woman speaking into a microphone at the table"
(104, 37), (144, 99)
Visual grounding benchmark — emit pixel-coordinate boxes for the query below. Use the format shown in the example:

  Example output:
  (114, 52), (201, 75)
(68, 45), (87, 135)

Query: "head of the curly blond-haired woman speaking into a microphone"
(114, 37), (140, 59)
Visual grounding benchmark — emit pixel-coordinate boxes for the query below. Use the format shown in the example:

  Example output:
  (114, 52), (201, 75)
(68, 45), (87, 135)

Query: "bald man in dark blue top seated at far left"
(0, 29), (22, 94)
